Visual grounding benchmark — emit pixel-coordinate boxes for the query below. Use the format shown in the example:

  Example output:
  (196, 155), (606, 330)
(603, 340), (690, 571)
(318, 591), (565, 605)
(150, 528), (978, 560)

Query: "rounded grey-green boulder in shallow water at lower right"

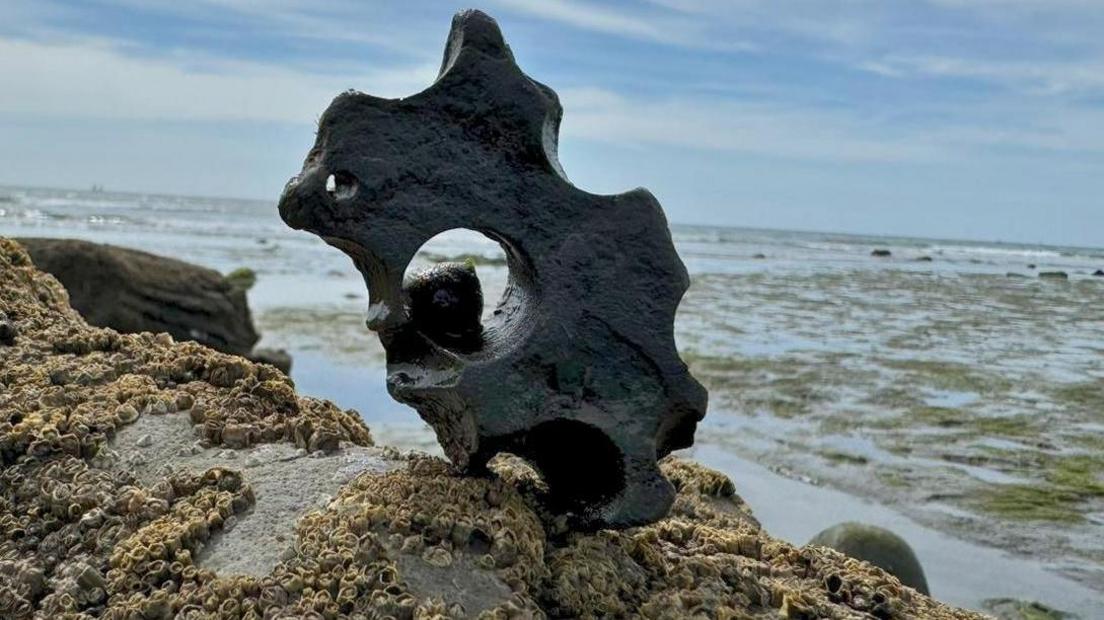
(809, 522), (931, 595)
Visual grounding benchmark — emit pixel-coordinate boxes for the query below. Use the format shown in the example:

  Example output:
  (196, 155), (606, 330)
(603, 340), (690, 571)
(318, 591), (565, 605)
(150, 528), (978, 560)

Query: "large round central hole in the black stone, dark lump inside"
(403, 228), (510, 352)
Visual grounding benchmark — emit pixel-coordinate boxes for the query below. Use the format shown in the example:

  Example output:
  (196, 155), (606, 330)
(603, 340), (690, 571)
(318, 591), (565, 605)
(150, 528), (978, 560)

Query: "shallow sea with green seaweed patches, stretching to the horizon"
(0, 185), (1104, 618)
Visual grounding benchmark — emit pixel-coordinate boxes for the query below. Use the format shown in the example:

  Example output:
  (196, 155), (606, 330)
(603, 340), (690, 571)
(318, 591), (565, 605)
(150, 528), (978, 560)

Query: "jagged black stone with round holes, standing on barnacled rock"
(279, 11), (707, 528)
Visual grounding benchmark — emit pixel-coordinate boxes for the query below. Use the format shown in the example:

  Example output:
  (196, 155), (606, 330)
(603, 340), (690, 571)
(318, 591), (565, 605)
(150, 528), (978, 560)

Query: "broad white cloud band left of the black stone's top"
(0, 39), (437, 122)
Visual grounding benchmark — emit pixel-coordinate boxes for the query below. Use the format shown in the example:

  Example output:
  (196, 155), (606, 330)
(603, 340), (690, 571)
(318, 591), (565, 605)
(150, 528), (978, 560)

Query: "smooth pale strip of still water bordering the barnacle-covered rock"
(280, 344), (1102, 619)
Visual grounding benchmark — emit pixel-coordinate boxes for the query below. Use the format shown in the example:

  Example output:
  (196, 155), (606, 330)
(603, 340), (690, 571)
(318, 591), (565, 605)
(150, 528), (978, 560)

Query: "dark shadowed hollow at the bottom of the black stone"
(518, 419), (625, 509)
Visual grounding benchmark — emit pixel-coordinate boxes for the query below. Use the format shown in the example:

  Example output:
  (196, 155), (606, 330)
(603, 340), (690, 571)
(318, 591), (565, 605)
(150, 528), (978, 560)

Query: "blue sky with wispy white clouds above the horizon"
(0, 0), (1104, 247)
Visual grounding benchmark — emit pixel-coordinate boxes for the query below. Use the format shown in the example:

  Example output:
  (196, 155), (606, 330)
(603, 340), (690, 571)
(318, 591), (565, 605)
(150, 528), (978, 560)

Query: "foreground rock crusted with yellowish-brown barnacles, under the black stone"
(0, 233), (979, 620)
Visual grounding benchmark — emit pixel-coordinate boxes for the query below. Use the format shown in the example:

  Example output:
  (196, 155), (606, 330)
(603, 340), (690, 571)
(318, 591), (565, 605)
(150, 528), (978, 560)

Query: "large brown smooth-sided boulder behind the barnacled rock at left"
(20, 238), (258, 355)
